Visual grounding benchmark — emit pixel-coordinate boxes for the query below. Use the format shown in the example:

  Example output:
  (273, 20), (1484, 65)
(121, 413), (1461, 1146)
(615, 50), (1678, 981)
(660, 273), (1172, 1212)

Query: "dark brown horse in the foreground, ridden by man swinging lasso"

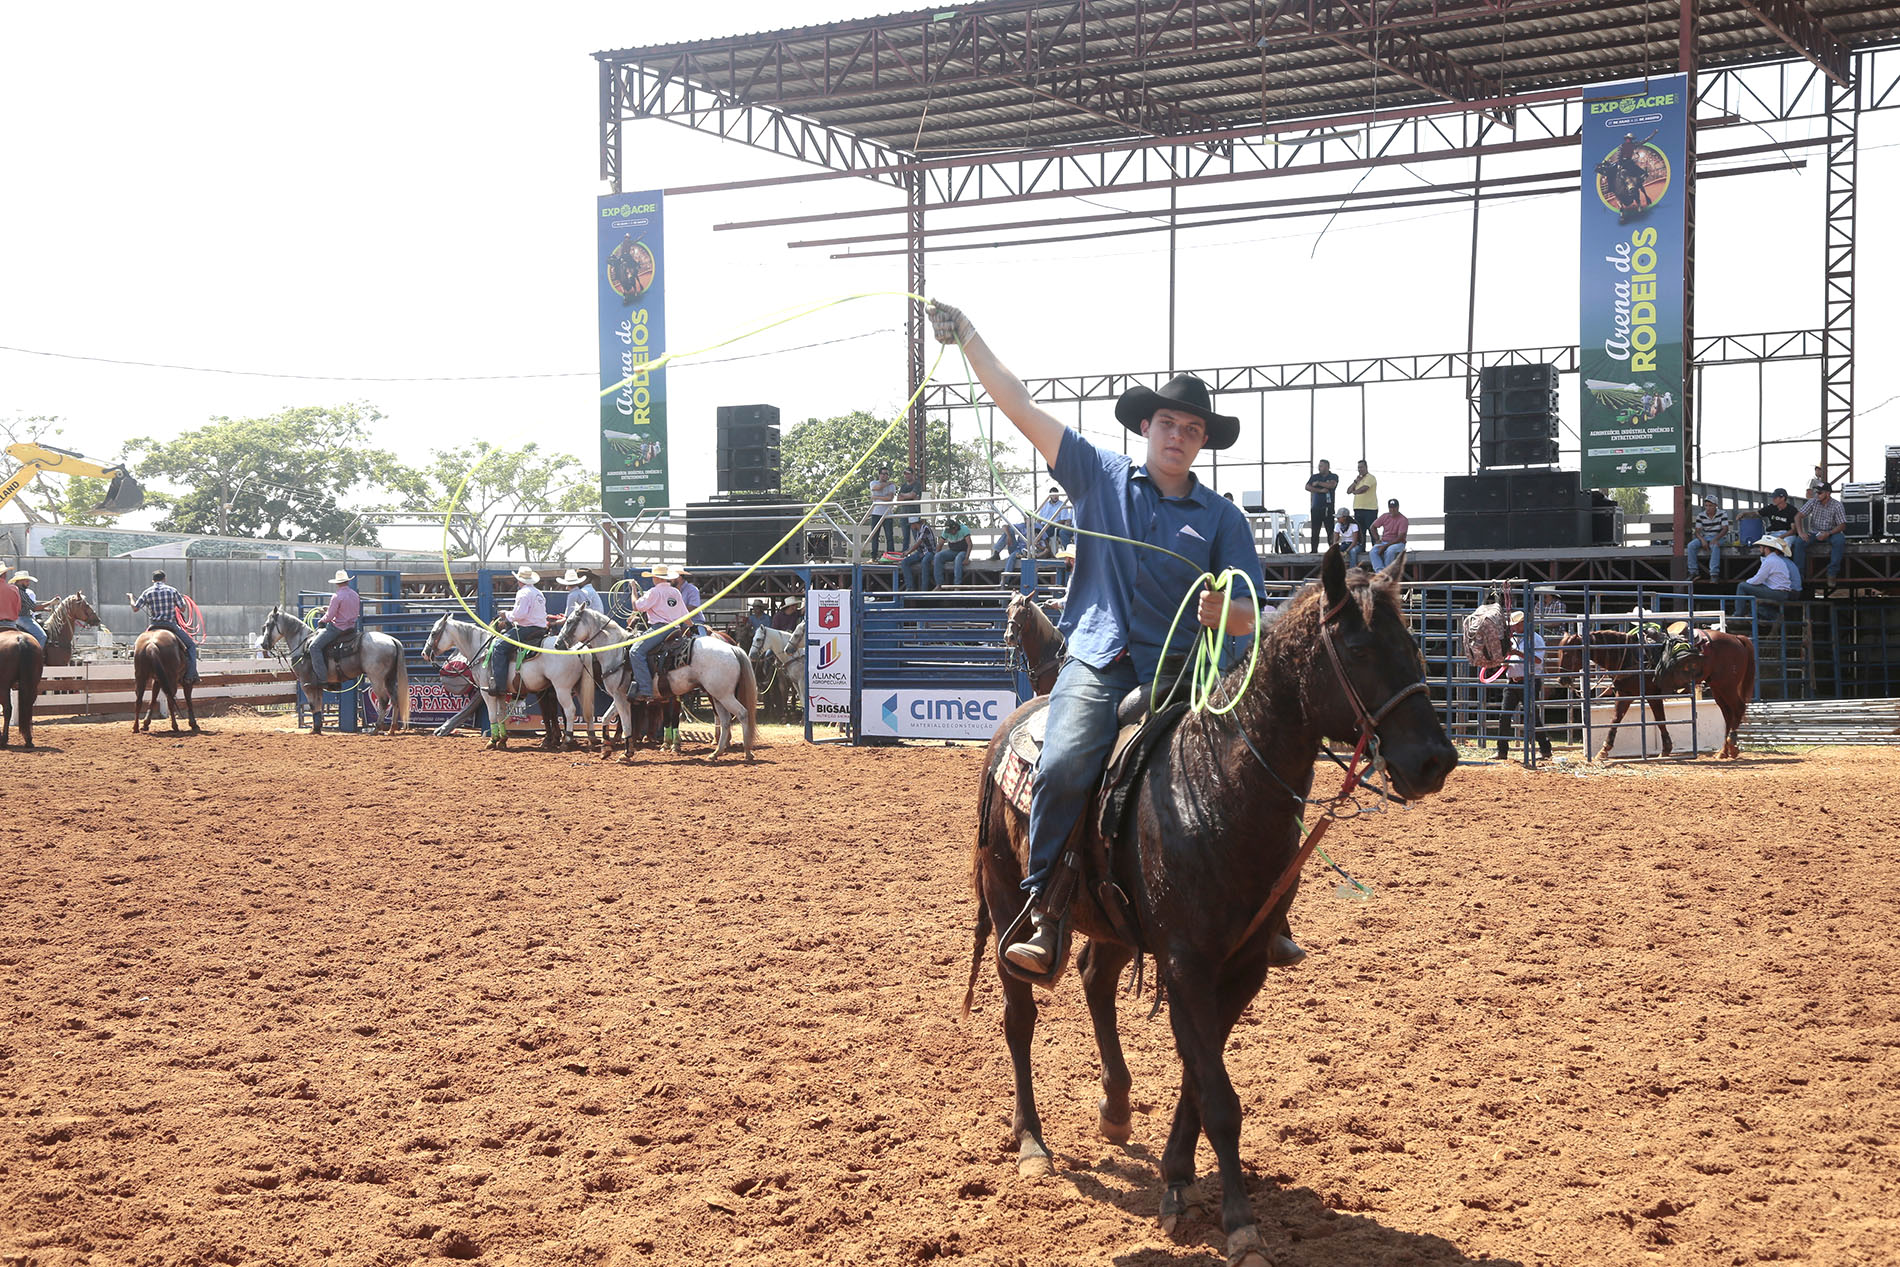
(965, 549), (1457, 1263)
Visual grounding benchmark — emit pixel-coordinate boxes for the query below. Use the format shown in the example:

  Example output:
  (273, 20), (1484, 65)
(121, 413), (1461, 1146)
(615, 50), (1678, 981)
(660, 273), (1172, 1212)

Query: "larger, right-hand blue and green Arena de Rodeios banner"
(1577, 74), (1695, 488)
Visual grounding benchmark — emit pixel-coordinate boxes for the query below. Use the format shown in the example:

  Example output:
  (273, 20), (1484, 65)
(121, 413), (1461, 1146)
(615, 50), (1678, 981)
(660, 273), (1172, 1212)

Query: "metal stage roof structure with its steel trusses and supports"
(595, 0), (1900, 505)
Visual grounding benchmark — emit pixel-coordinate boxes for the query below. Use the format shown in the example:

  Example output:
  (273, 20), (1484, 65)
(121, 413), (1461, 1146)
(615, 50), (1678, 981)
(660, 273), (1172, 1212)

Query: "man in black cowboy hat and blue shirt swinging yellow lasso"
(929, 302), (1269, 974)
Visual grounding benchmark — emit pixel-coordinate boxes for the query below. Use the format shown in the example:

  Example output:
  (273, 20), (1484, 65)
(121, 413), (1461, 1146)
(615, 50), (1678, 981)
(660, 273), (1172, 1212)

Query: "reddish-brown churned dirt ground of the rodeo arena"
(0, 718), (1900, 1267)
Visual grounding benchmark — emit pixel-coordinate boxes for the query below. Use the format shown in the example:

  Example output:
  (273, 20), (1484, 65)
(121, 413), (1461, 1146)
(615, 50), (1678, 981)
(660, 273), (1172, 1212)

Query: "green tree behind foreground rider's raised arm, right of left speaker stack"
(779, 410), (1028, 507)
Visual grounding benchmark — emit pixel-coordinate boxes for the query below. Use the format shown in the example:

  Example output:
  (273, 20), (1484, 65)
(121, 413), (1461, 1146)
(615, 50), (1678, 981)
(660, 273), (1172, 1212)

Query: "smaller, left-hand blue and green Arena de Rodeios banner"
(595, 190), (671, 519)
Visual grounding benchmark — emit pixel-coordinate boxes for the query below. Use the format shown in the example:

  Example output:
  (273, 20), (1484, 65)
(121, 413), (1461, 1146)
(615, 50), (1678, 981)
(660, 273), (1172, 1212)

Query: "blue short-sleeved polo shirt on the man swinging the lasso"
(1051, 429), (1262, 682)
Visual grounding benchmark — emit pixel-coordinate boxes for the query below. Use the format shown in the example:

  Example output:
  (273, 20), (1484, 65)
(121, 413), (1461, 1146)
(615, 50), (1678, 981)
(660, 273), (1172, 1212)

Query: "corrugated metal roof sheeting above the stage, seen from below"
(595, 0), (1900, 156)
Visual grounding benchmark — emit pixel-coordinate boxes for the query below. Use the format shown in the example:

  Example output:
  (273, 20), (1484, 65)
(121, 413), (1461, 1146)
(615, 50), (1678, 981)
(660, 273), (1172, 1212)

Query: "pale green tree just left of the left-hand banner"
(386, 441), (600, 558)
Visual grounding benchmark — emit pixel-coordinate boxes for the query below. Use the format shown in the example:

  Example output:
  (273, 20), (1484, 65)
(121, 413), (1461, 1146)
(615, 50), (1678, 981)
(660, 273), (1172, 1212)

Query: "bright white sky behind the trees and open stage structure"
(0, 0), (1900, 535)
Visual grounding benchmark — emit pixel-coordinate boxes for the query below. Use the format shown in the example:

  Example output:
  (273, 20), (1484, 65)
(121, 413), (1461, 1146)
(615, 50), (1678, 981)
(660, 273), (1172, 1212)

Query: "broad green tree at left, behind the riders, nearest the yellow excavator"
(129, 403), (395, 541)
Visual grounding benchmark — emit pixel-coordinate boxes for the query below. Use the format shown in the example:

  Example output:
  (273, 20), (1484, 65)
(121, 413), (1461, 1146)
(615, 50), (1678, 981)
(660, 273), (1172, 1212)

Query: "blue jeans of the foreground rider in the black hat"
(1022, 655), (1140, 893)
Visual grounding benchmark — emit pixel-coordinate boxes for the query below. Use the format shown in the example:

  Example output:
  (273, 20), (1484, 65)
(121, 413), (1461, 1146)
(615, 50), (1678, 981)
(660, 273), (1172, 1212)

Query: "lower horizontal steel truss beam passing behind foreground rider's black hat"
(923, 331), (1822, 412)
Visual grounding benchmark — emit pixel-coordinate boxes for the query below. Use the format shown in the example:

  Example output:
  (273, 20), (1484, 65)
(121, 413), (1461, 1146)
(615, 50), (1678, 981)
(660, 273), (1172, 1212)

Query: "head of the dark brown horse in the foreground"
(1296, 547), (1457, 796)
